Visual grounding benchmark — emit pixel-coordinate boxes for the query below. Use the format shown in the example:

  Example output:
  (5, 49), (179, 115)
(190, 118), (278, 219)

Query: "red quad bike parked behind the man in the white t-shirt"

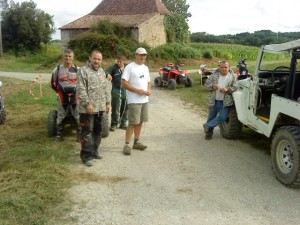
(154, 63), (193, 90)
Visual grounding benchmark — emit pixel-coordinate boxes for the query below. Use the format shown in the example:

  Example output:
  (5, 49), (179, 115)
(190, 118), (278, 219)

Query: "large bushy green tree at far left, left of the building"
(1, 0), (55, 52)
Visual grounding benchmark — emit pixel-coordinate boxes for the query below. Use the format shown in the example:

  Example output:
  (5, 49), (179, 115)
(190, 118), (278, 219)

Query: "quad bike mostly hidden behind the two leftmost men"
(48, 90), (109, 138)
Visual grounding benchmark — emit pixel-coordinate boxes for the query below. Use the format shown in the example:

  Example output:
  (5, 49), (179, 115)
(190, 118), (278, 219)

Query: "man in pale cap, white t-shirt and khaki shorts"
(122, 48), (151, 155)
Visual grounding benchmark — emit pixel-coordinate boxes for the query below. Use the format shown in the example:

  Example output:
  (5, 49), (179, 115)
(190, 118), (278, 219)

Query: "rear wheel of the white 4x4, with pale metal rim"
(271, 126), (300, 188)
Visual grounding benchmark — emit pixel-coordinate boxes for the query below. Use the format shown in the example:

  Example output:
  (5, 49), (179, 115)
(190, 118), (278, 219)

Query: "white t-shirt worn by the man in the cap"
(122, 62), (150, 104)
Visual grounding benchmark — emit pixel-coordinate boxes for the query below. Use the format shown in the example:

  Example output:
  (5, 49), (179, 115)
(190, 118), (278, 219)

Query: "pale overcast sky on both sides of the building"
(14, 0), (300, 39)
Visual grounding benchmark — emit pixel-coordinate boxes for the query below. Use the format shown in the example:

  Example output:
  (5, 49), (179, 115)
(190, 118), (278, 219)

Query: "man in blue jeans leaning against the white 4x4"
(203, 61), (237, 140)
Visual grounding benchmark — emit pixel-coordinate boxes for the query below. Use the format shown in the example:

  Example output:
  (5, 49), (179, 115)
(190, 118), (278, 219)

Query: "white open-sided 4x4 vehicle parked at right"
(220, 39), (300, 188)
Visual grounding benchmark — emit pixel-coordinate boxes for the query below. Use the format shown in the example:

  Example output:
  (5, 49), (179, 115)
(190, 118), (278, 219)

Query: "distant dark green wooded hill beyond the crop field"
(191, 30), (300, 46)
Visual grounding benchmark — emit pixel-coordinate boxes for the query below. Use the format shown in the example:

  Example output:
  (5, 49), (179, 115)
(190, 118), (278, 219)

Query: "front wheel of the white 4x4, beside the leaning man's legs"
(220, 106), (243, 139)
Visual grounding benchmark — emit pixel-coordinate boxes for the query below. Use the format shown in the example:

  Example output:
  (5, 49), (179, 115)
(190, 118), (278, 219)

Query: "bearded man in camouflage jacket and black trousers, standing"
(77, 50), (111, 166)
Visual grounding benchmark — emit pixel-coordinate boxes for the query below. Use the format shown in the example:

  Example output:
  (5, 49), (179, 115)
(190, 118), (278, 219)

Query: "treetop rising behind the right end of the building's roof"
(161, 0), (192, 21)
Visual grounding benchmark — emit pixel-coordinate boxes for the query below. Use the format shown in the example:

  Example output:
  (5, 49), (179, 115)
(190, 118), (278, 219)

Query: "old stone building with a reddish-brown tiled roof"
(59, 0), (170, 48)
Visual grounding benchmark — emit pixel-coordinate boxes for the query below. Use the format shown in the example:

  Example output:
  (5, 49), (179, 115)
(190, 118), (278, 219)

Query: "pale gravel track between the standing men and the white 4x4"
(0, 71), (300, 225)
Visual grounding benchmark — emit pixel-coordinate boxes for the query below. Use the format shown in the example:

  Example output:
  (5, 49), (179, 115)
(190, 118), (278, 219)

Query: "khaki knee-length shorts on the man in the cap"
(127, 102), (148, 125)
